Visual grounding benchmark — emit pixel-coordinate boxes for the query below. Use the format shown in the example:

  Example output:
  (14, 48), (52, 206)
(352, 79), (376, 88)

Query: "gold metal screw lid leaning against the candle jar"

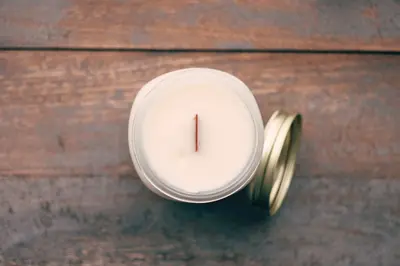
(248, 111), (302, 215)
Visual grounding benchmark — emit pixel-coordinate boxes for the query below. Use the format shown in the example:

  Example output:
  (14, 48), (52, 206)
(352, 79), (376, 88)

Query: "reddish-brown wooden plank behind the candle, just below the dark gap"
(0, 52), (400, 178)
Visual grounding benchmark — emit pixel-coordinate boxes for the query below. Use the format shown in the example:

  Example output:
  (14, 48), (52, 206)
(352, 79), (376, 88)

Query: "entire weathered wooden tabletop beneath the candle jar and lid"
(0, 0), (400, 266)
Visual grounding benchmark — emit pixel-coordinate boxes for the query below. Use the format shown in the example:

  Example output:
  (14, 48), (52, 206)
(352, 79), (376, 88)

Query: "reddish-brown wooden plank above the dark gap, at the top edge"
(0, 0), (400, 51)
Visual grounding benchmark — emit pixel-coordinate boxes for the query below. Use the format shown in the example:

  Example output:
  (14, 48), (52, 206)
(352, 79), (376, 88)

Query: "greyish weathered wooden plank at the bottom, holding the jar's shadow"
(0, 175), (400, 266)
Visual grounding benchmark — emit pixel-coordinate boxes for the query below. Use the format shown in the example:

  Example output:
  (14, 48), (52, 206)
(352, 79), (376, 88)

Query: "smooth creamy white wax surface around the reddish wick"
(141, 71), (255, 193)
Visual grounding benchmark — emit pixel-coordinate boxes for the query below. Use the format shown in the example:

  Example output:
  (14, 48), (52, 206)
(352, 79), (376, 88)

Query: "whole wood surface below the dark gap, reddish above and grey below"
(0, 51), (400, 266)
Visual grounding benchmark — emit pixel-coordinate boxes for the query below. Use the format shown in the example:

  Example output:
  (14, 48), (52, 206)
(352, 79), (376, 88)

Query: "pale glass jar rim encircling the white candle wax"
(128, 68), (264, 203)
